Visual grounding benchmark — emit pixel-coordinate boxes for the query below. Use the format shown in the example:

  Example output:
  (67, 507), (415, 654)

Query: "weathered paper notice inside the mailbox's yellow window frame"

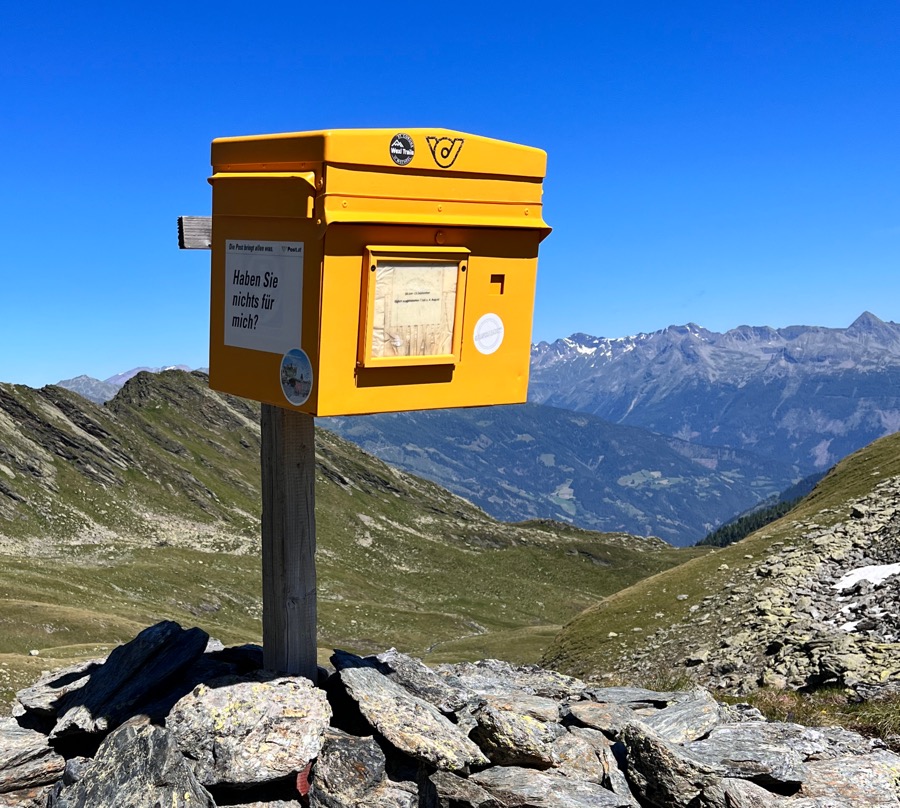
(372, 261), (459, 357)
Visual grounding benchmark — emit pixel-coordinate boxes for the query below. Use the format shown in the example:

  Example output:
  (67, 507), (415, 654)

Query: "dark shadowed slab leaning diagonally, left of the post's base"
(50, 621), (209, 738)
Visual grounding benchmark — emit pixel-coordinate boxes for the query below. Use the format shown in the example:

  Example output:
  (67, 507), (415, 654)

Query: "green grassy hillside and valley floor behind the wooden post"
(0, 371), (700, 703)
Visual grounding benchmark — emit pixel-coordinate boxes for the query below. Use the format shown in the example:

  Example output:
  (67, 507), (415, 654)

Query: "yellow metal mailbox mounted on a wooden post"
(209, 129), (550, 415)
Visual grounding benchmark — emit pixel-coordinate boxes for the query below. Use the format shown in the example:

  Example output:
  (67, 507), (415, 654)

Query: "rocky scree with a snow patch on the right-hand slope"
(631, 477), (900, 695)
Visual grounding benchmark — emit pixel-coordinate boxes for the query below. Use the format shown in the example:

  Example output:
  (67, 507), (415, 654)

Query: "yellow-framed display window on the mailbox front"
(360, 248), (467, 367)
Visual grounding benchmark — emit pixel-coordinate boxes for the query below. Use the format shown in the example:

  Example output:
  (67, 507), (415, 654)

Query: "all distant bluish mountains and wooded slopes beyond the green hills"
(60, 312), (900, 546)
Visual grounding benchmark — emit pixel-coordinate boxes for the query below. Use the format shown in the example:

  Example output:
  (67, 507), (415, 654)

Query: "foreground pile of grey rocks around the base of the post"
(0, 623), (900, 808)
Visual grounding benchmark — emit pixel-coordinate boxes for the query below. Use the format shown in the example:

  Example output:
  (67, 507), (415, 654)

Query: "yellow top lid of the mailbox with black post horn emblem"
(212, 128), (547, 180)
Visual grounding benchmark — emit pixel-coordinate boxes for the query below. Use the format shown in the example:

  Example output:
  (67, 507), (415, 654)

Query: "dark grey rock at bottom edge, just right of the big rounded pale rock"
(309, 729), (385, 808)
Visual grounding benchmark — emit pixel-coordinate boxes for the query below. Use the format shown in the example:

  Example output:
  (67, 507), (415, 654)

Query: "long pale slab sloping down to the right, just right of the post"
(337, 668), (488, 772)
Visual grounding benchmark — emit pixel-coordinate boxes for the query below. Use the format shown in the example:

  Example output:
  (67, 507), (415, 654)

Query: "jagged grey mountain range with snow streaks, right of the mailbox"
(529, 312), (900, 476)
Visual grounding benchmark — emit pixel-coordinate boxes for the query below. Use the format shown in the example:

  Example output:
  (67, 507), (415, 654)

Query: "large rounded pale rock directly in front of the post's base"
(166, 671), (331, 785)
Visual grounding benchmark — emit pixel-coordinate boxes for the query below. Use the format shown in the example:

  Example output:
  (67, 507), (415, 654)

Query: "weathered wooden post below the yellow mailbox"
(260, 404), (317, 682)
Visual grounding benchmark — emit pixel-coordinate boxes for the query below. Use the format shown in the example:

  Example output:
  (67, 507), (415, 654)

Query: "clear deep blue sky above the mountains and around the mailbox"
(0, 0), (900, 386)
